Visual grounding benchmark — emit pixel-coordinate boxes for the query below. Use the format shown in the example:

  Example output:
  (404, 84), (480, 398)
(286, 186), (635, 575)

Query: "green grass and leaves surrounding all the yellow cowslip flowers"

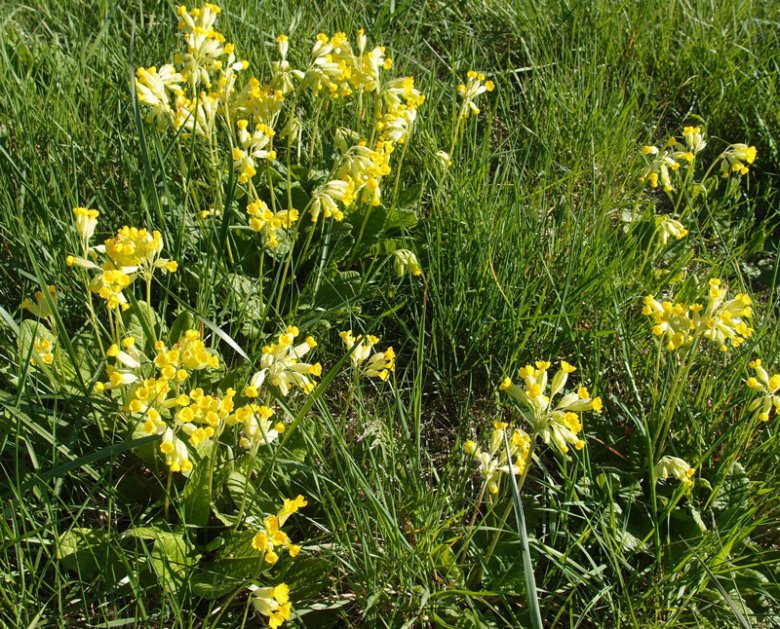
(0, 0), (780, 627)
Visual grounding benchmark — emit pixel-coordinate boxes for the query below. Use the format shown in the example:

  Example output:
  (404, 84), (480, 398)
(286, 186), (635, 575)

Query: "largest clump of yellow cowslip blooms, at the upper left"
(135, 3), (426, 244)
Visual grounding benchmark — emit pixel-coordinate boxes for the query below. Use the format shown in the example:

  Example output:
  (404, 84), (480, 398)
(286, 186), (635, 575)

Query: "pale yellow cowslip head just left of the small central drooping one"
(250, 326), (322, 397)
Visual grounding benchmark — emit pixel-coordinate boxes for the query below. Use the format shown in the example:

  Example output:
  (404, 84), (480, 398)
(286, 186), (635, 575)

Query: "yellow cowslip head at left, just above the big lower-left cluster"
(65, 208), (178, 310)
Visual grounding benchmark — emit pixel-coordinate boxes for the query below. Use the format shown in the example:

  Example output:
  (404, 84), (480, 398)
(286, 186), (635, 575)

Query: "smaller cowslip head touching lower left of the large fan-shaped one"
(463, 421), (531, 495)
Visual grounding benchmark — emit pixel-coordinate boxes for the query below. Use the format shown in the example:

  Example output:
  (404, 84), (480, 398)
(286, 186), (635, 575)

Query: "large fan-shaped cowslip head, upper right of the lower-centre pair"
(499, 360), (602, 454)
